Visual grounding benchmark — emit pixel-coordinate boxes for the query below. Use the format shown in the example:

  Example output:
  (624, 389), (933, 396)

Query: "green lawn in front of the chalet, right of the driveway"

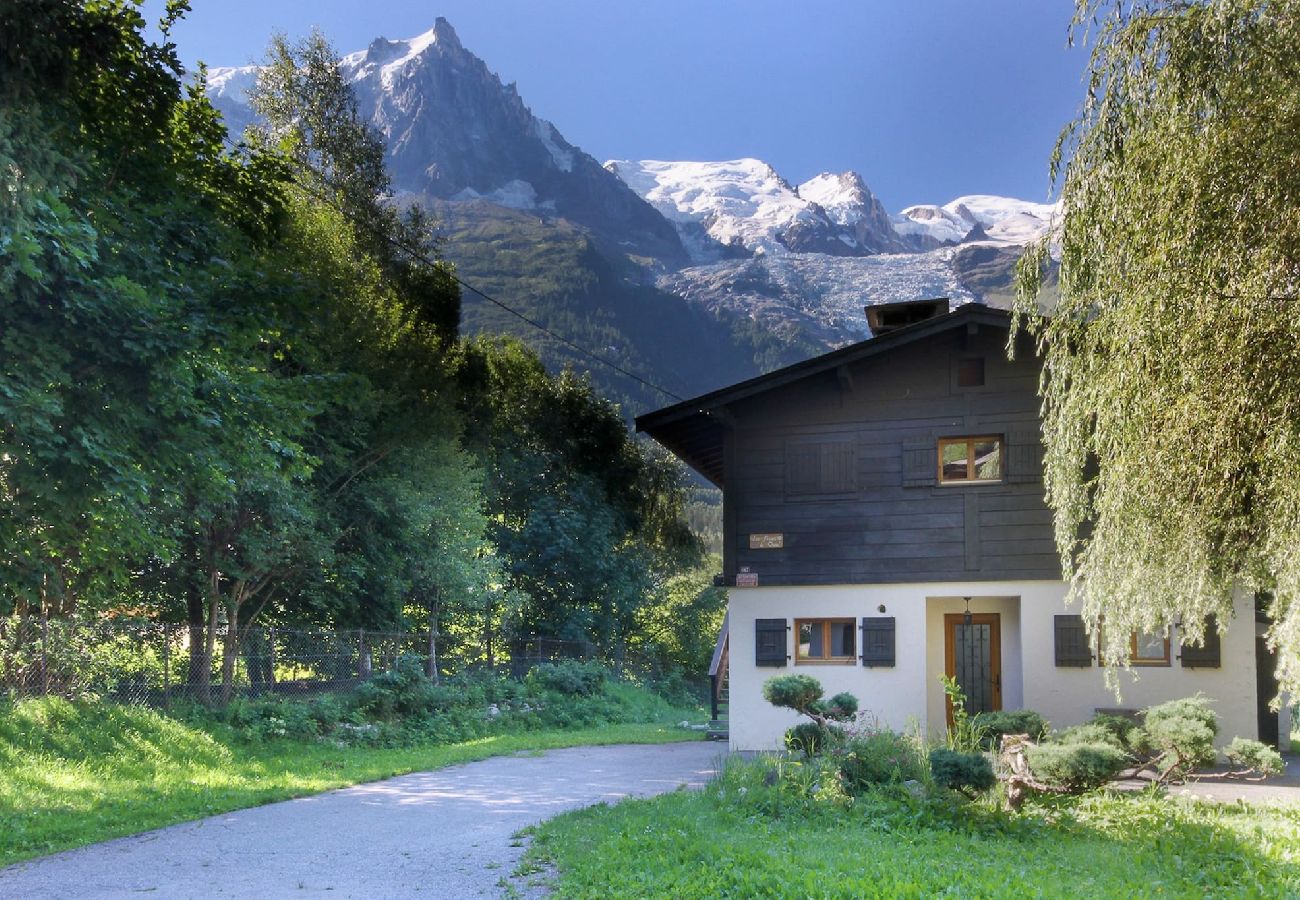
(521, 763), (1300, 897)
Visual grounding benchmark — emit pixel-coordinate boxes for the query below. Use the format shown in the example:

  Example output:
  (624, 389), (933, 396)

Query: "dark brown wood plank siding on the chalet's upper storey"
(724, 325), (1061, 585)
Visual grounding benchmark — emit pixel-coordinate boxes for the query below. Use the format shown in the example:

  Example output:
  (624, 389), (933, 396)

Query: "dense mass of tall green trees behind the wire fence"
(0, 3), (702, 686)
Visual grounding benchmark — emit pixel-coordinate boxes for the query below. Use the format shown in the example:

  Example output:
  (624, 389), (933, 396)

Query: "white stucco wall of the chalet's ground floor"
(728, 581), (1257, 750)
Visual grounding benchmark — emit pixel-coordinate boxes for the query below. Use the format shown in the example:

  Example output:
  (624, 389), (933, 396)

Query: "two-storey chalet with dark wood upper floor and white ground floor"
(637, 300), (1277, 750)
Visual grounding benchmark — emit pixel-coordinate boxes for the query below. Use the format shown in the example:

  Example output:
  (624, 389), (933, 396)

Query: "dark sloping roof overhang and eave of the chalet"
(636, 303), (1011, 488)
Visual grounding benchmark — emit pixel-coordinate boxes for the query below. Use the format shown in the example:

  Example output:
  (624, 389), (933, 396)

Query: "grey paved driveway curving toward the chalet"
(0, 741), (724, 900)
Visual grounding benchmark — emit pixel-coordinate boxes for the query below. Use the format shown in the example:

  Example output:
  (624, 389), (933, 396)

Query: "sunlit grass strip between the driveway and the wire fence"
(0, 700), (699, 865)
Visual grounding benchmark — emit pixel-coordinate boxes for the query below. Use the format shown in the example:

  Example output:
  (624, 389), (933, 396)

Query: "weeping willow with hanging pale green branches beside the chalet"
(1018, 0), (1300, 691)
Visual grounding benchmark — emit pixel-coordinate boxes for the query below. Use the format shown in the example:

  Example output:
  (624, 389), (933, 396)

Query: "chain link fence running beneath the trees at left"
(0, 616), (660, 706)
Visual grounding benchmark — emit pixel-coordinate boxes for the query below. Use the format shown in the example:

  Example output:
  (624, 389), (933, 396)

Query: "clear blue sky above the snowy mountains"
(146, 0), (1087, 212)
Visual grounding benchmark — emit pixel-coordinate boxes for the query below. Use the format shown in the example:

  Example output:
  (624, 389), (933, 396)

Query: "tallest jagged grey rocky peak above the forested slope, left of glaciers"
(208, 17), (683, 261)
